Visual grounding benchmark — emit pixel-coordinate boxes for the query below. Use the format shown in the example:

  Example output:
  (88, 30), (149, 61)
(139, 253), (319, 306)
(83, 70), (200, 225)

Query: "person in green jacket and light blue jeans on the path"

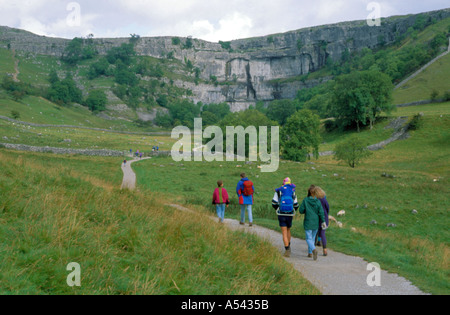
(300, 186), (326, 260)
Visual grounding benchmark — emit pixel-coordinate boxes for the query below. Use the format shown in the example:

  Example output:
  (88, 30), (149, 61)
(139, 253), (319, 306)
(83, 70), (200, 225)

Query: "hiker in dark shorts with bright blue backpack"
(272, 178), (299, 258)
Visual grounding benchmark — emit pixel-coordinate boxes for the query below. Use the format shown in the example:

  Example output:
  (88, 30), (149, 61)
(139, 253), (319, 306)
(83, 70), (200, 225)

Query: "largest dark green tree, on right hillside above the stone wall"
(332, 70), (395, 132)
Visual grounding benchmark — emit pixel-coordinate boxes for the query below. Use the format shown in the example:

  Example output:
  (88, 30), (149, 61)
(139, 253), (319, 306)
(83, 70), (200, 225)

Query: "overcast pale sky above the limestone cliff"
(0, 0), (450, 42)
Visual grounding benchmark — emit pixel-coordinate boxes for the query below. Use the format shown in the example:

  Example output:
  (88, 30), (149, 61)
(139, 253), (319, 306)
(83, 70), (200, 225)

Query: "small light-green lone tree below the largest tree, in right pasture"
(334, 136), (372, 168)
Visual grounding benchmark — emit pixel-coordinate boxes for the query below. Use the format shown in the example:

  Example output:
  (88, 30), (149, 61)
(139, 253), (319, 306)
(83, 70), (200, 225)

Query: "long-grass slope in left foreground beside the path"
(0, 150), (319, 295)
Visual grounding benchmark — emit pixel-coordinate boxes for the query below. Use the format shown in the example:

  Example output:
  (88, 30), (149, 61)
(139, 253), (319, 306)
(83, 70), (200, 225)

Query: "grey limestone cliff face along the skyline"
(0, 9), (450, 111)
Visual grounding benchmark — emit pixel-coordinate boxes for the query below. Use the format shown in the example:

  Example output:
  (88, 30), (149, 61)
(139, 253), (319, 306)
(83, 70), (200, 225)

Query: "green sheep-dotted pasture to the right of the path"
(135, 104), (450, 294)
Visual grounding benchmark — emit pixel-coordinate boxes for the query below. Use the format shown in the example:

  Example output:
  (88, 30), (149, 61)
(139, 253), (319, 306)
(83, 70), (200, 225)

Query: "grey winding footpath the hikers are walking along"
(122, 160), (425, 295)
